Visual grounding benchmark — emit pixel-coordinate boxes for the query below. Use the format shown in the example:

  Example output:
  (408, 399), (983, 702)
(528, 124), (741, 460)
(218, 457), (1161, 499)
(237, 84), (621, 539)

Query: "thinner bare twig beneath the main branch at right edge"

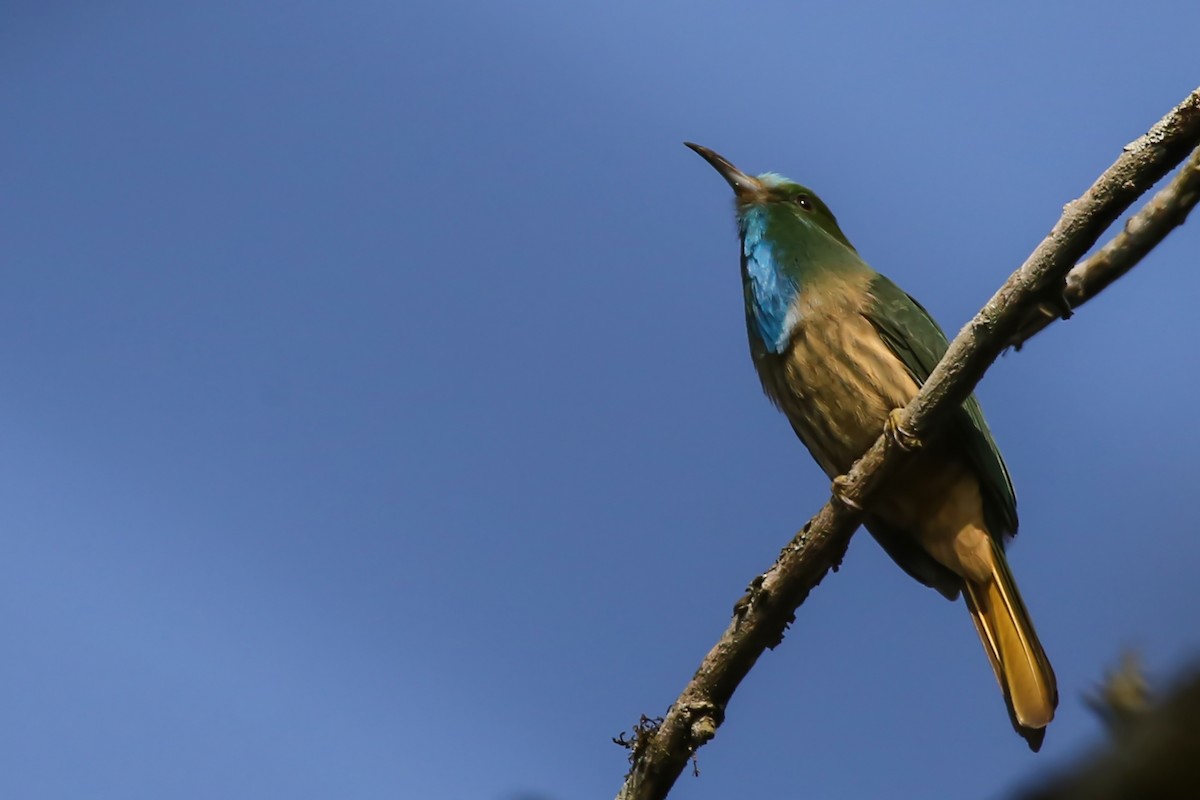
(1013, 148), (1200, 350)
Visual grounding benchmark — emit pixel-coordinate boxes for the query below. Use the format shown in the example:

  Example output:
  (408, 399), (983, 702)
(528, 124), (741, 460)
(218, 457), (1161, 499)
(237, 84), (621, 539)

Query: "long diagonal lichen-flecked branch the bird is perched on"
(617, 89), (1200, 800)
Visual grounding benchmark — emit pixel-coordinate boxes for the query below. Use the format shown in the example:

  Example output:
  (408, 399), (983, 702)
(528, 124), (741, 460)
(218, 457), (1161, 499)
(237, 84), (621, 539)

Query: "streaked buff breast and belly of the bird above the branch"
(763, 313), (918, 477)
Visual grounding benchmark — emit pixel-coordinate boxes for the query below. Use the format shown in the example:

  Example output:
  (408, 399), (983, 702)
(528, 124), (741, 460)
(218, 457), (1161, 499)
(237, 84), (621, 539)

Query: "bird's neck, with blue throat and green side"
(738, 206), (871, 353)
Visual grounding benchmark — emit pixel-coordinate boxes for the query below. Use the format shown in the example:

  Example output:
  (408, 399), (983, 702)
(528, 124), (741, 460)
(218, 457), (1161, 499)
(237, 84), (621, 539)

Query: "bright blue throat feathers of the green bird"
(738, 206), (800, 354)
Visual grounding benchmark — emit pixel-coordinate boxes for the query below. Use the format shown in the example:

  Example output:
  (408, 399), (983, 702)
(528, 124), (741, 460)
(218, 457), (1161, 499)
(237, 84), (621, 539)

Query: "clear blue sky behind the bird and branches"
(0, 0), (1200, 800)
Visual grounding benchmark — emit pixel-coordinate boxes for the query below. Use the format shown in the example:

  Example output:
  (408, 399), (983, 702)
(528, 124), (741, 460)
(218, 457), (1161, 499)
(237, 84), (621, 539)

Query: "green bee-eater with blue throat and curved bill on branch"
(684, 142), (1058, 752)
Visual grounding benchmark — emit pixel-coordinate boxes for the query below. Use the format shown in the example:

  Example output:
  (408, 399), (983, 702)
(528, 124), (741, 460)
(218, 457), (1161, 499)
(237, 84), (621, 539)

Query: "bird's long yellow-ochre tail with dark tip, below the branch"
(964, 537), (1058, 752)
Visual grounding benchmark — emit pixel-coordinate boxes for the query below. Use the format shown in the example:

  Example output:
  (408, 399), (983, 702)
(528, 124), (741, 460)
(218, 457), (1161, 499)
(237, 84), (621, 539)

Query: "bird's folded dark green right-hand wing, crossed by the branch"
(865, 275), (1016, 542)
